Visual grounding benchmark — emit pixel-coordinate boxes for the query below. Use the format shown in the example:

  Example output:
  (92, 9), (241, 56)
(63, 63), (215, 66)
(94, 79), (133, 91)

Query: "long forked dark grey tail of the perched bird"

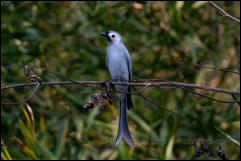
(115, 95), (134, 146)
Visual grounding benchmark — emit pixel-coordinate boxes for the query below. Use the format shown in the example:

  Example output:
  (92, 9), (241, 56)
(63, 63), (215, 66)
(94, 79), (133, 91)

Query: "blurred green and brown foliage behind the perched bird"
(1, 1), (240, 159)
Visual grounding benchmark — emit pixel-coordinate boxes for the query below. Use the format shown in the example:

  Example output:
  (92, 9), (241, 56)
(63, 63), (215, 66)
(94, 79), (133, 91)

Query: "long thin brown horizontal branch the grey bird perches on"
(1, 65), (240, 105)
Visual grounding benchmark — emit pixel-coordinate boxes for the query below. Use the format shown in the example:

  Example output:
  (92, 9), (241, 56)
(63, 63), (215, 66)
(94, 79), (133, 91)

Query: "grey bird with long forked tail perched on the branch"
(100, 31), (134, 146)
